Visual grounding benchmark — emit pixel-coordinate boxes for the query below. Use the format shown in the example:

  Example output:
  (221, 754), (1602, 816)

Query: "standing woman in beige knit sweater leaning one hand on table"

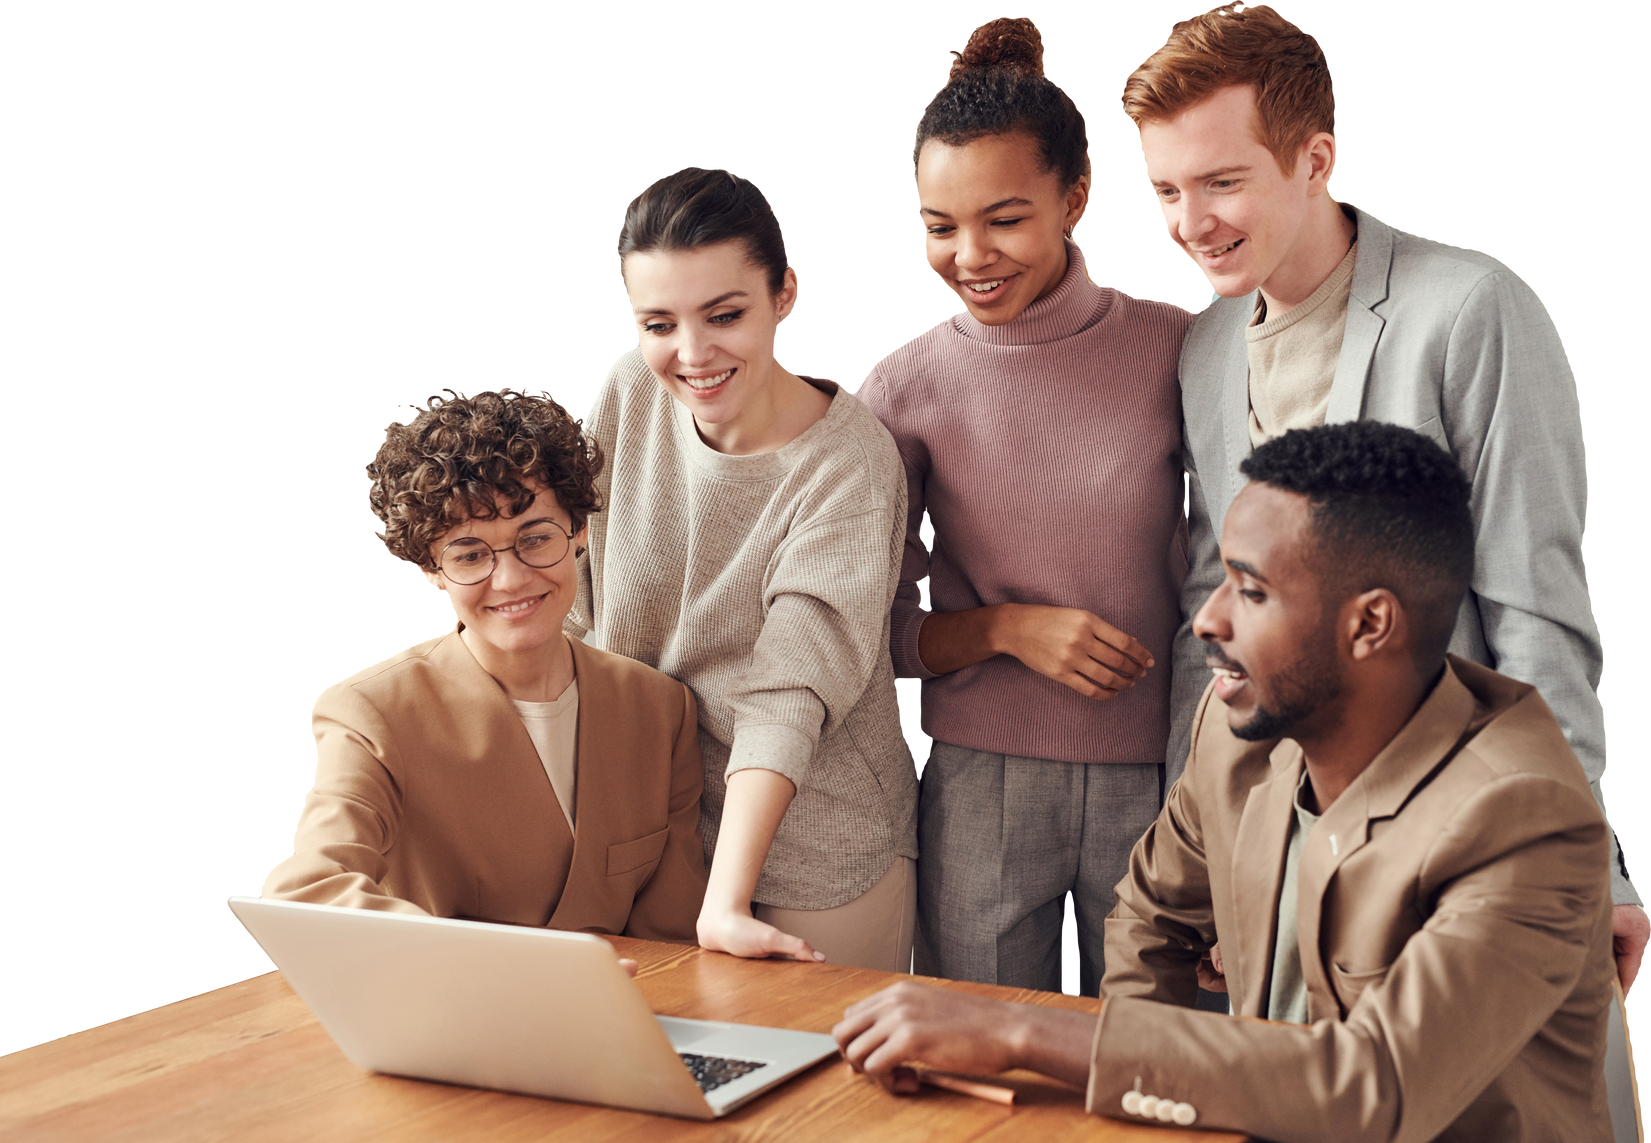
(568, 167), (916, 971)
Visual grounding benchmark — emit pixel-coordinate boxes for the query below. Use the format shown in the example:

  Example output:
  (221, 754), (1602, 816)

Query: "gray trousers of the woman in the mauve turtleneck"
(916, 742), (1164, 996)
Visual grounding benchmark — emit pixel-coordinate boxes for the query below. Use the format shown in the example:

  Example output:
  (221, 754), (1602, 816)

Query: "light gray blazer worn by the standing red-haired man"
(1167, 206), (1633, 900)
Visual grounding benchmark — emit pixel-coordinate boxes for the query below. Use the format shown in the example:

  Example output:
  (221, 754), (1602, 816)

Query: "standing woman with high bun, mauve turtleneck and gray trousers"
(859, 17), (1192, 996)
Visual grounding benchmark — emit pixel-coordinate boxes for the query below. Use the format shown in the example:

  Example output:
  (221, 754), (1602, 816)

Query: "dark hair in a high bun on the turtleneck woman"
(911, 17), (1090, 190)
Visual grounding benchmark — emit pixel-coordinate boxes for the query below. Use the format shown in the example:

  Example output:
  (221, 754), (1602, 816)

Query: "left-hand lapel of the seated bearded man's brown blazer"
(1220, 738), (1301, 1016)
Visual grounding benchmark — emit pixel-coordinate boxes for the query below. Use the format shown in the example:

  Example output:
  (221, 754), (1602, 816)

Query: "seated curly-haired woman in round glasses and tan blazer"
(263, 388), (705, 941)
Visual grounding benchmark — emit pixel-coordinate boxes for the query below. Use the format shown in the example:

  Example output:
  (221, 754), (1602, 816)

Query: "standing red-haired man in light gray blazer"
(1123, 3), (1651, 991)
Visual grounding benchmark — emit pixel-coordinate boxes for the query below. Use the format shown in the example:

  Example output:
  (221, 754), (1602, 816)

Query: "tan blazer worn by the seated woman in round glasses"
(261, 626), (705, 941)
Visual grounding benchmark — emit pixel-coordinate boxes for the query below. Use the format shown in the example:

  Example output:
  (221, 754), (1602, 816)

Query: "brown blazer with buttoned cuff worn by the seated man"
(1088, 656), (1615, 1143)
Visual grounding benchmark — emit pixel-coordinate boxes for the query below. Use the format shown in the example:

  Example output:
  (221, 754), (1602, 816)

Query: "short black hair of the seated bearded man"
(1238, 421), (1473, 669)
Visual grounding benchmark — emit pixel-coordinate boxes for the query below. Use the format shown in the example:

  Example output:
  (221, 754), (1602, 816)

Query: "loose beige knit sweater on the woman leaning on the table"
(568, 350), (916, 908)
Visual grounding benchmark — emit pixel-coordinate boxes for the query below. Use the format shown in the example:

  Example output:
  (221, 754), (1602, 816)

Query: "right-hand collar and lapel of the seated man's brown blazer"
(1296, 666), (1474, 1019)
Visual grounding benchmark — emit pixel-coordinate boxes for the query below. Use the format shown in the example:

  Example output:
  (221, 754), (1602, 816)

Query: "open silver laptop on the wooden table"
(225, 894), (837, 1120)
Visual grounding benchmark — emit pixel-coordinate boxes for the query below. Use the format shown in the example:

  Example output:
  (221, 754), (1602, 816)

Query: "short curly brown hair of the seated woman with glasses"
(367, 388), (604, 570)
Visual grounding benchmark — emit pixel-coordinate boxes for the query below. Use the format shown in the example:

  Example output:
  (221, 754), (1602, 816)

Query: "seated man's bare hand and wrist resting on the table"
(832, 983), (1095, 1093)
